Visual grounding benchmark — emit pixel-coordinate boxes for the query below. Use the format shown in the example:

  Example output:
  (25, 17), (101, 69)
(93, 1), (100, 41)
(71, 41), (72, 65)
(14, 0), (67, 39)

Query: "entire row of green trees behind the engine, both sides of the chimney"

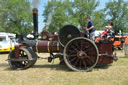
(0, 0), (128, 34)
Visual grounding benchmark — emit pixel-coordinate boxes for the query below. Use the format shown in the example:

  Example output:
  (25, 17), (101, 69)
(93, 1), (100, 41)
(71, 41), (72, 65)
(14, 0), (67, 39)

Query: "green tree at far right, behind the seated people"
(105, 0), (128, 33)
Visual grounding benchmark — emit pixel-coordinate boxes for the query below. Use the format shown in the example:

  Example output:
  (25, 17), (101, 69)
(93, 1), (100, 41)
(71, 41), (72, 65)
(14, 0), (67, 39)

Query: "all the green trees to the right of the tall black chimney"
(43, 0), (128, 32)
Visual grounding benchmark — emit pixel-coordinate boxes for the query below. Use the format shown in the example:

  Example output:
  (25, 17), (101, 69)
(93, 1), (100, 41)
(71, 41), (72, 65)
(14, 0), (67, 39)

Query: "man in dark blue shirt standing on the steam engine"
(85, 17), (95, 41)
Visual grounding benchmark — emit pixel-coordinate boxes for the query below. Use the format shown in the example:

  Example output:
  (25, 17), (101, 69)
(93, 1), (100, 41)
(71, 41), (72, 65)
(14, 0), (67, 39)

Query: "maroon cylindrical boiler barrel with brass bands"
(36, 40), (60, 53)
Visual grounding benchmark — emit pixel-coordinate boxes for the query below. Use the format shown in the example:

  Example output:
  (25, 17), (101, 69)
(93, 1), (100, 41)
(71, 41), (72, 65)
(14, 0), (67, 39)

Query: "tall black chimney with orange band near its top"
(32, 8), (38, 39)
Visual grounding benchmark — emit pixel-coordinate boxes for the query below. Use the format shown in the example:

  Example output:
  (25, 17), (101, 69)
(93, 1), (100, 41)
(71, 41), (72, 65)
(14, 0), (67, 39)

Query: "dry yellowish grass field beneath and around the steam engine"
(0, 51), (128, 85)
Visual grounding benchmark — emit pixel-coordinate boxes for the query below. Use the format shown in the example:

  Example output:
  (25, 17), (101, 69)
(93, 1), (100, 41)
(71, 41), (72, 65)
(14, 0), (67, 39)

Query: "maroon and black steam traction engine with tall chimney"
(8, 9), (117, 71)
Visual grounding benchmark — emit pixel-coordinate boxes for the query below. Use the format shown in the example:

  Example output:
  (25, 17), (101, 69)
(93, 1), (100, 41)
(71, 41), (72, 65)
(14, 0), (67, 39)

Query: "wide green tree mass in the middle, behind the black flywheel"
(43, 0), (104, 32)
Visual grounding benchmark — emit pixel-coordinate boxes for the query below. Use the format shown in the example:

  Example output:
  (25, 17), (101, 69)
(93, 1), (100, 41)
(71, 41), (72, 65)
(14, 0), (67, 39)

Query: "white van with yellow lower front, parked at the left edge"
(0, 32), (17, 52)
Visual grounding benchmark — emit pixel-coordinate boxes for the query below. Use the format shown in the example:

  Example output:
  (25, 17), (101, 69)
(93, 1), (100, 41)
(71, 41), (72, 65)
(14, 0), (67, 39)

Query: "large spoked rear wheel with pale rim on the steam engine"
(64, 37), (99, 71)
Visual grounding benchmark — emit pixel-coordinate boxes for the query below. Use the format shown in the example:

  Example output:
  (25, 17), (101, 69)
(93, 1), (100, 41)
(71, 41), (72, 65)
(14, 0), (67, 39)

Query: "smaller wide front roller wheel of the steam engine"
(8, 47), (37, 69)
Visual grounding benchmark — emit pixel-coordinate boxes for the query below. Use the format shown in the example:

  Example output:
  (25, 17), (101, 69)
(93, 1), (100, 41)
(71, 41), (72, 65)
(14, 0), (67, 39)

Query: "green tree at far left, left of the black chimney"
(1, 0), (32, 34)
